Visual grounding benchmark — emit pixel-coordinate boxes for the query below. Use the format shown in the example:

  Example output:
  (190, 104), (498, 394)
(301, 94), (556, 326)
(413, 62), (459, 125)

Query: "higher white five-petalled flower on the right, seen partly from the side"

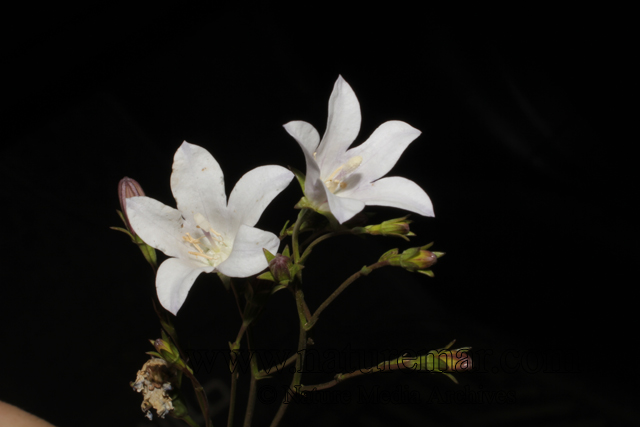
(284, 76), (434, 224)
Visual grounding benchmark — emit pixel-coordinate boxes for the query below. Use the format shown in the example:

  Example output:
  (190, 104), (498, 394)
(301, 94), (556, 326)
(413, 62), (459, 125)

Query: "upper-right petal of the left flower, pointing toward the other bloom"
(228, 166), (294, 230)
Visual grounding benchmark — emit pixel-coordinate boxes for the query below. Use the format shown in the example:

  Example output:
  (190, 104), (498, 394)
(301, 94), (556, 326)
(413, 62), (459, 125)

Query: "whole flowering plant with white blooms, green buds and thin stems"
(114, 77), (472, 427)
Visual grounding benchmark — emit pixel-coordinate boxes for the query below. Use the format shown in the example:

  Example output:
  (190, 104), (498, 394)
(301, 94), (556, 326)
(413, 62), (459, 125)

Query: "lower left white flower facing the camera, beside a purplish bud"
(127, 142), (293, 314)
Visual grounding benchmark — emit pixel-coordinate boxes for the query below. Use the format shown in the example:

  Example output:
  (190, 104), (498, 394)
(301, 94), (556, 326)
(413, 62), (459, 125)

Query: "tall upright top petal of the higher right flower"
(316, 76), (361, 173)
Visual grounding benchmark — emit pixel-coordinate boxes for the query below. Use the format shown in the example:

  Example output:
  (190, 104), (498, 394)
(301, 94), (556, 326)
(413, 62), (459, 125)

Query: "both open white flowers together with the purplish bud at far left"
(121, 76), (433, 314)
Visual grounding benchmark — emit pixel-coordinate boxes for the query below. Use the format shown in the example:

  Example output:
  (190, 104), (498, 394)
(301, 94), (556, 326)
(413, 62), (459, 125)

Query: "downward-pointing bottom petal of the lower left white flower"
(156, 258), (214, 314)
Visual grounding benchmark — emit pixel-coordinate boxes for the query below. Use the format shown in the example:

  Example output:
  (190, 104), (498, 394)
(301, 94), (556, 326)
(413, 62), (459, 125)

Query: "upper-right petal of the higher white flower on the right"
(340, 120), (421, 186)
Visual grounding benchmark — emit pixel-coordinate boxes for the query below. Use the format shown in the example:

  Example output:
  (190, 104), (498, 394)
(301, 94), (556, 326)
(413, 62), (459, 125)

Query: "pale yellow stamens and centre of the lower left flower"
(182, 213), (231, 267)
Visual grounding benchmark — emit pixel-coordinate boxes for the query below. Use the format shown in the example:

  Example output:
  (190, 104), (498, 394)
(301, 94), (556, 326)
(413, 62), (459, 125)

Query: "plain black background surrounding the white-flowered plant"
(0, 3), (638, 426)
